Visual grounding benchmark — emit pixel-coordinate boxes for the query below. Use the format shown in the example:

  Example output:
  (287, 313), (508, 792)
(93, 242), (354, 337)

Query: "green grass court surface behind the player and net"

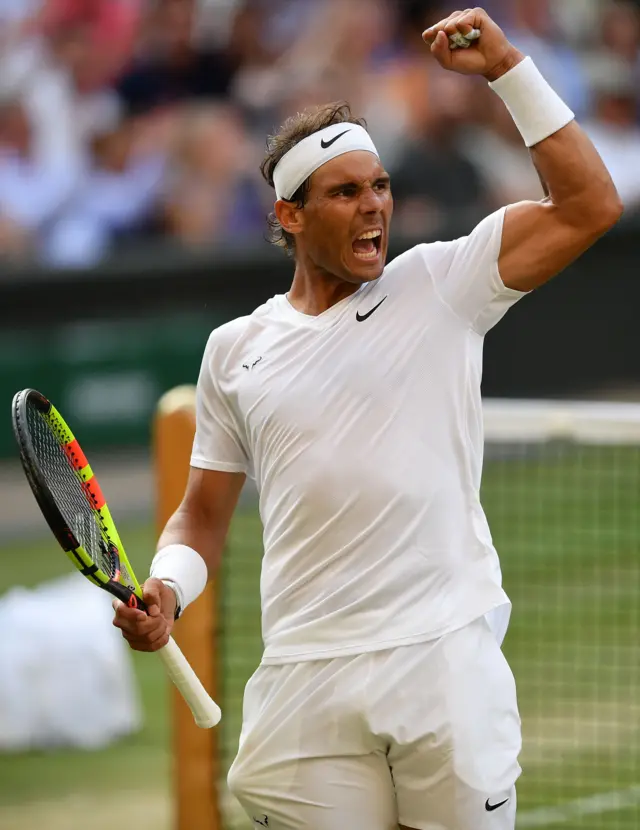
(0, 446), (640, 830)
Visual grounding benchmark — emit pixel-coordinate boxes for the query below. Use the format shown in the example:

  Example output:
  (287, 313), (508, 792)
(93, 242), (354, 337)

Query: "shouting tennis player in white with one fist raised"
(115, 9), (621, 830)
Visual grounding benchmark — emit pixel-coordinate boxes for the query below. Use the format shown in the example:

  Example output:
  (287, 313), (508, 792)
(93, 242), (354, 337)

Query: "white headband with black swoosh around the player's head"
(273, 122), (378, 199)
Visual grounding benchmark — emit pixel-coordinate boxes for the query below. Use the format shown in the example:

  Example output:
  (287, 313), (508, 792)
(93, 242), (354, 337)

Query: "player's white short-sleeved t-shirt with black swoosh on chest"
(191, 209), (523, 663)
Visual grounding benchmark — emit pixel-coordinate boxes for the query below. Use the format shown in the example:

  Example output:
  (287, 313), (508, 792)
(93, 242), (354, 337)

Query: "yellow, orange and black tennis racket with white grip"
(11, 389), (221, 729)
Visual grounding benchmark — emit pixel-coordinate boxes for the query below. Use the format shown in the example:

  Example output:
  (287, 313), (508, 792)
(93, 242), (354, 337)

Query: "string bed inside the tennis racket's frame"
(27, 406), (119, 581)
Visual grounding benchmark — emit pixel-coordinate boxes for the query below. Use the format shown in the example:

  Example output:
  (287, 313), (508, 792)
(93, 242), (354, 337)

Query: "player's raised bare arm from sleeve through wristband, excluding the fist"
(491, 51), (622, 291)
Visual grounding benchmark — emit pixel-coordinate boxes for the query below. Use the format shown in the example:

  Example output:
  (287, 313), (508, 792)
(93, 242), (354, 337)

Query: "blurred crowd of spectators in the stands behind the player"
(0, 0), (640, 267)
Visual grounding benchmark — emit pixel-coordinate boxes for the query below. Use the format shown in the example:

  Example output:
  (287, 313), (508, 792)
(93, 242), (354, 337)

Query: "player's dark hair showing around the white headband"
(260, 101), (367, 256)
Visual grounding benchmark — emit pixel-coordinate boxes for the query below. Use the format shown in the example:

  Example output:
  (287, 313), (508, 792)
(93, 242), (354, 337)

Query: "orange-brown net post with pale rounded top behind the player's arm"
(153, 386), (222, 830)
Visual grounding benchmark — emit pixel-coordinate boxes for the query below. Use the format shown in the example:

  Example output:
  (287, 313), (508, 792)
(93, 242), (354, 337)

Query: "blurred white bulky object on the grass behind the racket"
(0, 574), (142, 751)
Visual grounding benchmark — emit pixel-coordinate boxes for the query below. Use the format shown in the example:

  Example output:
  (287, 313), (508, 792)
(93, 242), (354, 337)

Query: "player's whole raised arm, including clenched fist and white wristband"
(423, 9), (622, 291)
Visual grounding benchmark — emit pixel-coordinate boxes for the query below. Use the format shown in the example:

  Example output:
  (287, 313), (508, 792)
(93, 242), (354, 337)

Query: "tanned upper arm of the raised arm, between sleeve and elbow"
(498, 199), (600, 291)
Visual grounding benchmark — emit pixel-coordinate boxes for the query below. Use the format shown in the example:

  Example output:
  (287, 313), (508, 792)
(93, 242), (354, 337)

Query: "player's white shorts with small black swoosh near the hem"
(229, 617), (521, 830)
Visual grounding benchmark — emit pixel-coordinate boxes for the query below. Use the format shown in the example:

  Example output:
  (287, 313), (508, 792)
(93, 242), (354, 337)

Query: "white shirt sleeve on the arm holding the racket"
(191, 332), (249, 473)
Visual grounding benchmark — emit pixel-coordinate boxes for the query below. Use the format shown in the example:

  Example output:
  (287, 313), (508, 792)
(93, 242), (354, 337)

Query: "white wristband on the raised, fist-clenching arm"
(489, 58), (575, 147)
